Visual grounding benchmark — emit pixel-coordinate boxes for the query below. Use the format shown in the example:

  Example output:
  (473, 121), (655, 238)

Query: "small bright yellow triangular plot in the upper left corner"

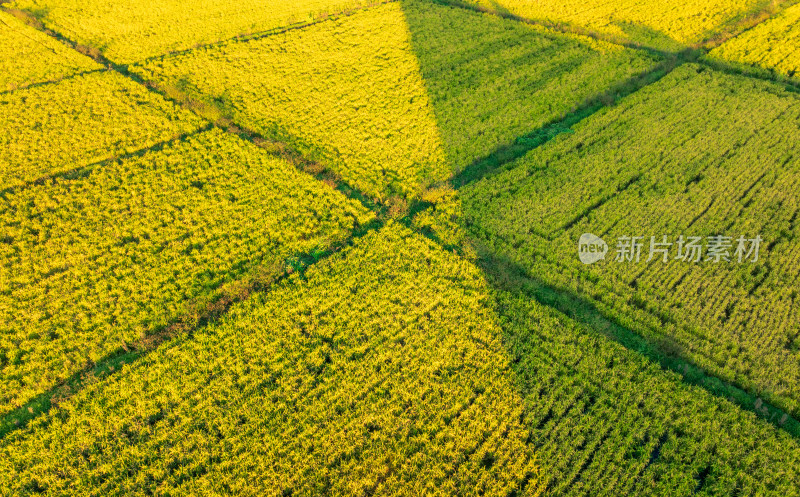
(0, 11), (102, 91)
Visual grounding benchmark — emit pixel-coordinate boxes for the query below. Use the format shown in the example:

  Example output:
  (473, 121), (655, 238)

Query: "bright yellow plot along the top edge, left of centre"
(10, 0), (377, 64)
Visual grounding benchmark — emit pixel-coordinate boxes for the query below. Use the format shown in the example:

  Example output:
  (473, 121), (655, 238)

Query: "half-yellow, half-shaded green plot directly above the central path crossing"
(132, 1), (655, 198)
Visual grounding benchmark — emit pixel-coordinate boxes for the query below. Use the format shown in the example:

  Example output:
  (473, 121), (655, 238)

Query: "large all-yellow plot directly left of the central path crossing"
(0, 130), (373, 414)
